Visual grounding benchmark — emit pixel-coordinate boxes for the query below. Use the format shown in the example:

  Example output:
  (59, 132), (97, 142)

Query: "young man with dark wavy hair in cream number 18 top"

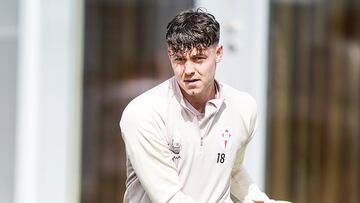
(120, 10), (290, 203)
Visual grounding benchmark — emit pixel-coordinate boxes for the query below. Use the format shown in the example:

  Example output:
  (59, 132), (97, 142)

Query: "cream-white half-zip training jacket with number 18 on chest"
(120, 77), (268, 203)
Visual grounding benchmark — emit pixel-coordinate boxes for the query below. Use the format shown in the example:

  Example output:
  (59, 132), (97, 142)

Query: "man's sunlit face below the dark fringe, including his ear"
(168, 45), (223, 101)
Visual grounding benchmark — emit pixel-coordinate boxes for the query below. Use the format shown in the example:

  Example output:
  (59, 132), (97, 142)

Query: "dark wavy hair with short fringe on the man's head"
(166, 8), (220, 53)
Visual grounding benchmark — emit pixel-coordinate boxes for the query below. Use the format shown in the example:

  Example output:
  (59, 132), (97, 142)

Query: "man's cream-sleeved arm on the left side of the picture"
(120, 104), (194, 203)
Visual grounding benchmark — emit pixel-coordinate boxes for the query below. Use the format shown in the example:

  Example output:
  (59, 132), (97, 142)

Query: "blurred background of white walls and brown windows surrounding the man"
(0, 0), (360, 203)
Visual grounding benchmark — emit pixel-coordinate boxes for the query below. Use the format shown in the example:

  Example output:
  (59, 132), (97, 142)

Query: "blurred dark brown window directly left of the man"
(81, 0), (193, 203)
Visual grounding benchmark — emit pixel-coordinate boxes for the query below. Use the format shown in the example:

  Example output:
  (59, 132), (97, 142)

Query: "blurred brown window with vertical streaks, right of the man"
(267, 0), (360, 203)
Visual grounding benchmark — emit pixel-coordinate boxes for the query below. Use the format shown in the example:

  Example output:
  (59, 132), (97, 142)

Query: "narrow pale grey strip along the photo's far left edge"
(0, 0), (18, 203)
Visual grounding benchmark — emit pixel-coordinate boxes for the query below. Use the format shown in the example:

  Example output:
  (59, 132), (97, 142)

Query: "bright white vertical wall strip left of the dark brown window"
(14, 0), (83, 203)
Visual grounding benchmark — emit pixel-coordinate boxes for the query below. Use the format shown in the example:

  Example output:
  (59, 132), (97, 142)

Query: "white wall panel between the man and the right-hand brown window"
(195, 0), (269, 189)
